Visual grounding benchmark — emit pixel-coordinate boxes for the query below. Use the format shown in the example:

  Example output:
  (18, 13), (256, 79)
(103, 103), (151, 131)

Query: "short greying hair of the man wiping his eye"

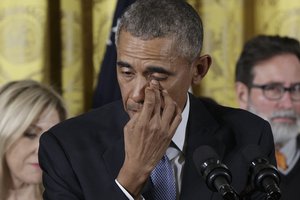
(115, 0), (203, 61)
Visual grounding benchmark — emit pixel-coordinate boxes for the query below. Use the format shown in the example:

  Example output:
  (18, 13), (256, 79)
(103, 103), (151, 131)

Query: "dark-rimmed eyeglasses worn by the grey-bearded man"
(251, 83), (300, 101)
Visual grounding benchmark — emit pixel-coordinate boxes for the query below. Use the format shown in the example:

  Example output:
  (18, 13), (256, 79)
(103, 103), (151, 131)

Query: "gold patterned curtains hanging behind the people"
(0, 0), (300, 117)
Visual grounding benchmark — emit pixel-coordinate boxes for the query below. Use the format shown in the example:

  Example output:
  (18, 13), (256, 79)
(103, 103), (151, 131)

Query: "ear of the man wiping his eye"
(192, 55), (212, 85)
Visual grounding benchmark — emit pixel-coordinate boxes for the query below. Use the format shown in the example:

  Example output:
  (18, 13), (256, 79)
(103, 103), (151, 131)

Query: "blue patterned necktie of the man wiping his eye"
(143, 155), (176, 200)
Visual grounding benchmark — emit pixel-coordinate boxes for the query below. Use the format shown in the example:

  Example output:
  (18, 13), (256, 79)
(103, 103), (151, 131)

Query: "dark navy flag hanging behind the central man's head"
(93, 0), (134, 108)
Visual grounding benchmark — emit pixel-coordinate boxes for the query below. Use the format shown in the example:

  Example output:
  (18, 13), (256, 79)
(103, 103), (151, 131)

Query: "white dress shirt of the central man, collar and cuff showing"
(115, 94), (190, 200)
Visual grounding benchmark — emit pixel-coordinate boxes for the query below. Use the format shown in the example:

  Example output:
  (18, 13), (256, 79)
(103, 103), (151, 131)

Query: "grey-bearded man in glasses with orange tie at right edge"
(236, 35), (300, 200)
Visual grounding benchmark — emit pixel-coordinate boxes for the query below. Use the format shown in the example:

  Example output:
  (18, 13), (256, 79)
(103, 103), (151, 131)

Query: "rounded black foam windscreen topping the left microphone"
(193, 145), (219, 167)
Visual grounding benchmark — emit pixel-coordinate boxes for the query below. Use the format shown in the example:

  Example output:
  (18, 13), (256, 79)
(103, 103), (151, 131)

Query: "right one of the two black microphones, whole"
(242, 145), (281, 200)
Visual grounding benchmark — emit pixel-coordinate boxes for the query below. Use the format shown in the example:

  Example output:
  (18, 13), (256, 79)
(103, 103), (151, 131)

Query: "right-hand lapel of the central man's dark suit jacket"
(180, 95), (225, 200)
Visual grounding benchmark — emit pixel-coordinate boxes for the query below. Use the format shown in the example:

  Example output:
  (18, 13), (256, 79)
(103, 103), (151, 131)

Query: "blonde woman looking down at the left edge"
(0, 80), (66, 200)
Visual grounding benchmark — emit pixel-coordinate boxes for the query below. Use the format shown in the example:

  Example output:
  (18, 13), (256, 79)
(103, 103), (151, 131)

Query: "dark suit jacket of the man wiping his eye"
(39, 95), (275, 200)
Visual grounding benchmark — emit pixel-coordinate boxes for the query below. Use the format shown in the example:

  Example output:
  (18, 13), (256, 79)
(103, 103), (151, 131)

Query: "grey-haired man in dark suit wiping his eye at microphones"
(39, 0), (275, 200)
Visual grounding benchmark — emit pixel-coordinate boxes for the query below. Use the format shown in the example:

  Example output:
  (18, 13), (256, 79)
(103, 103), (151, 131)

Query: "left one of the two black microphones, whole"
(193, 145), (239, 200)
